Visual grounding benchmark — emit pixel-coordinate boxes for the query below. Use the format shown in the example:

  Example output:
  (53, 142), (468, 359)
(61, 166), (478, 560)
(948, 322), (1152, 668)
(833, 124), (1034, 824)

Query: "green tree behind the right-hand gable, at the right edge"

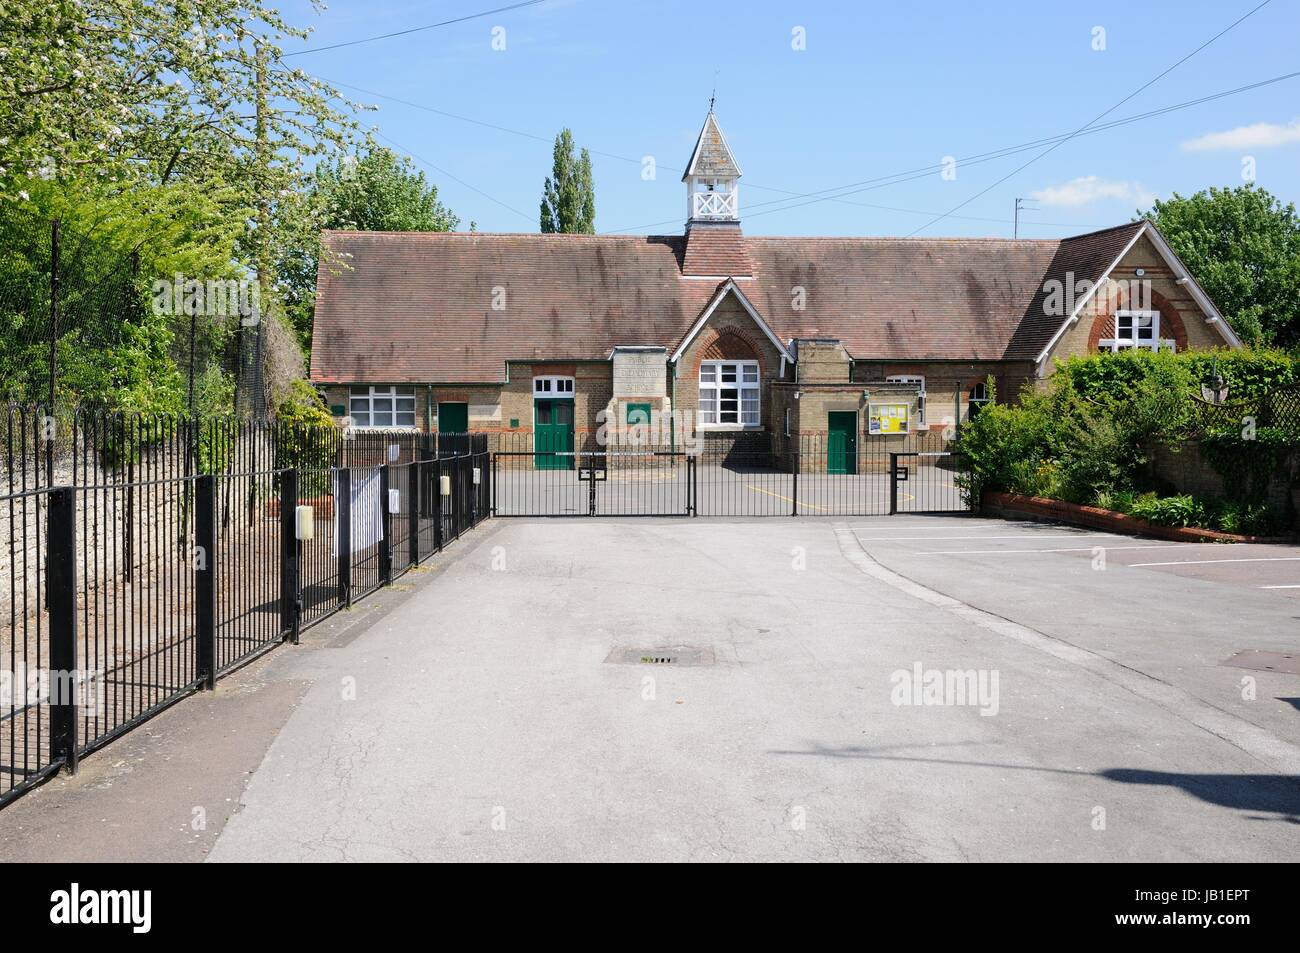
(1144, 186), (1300, 347)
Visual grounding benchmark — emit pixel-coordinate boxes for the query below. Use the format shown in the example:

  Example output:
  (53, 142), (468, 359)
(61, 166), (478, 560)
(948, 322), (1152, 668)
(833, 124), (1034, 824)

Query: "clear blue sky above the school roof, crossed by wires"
(282, 0), (1300, 238)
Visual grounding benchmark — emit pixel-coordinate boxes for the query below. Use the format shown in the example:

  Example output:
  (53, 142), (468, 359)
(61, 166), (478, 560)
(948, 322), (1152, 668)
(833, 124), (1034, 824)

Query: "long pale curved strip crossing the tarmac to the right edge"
(835, 528), (1300, 775)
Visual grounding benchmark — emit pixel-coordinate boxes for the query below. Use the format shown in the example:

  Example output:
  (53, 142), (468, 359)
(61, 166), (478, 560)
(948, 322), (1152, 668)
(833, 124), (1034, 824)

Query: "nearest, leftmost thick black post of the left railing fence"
(46, 486), (79, 771)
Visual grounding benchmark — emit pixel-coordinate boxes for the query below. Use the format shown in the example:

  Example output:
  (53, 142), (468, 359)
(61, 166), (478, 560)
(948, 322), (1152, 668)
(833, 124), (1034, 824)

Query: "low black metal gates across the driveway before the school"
(491, 434), (970, 516)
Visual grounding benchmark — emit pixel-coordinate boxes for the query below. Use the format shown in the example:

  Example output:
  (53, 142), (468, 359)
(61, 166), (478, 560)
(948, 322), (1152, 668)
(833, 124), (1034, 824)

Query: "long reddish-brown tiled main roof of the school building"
(312, 225), (1140, 384)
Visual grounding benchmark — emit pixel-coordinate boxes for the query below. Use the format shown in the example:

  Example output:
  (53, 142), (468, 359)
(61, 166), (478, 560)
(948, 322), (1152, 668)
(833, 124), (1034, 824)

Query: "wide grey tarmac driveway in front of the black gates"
(0, 517), (1300, 861)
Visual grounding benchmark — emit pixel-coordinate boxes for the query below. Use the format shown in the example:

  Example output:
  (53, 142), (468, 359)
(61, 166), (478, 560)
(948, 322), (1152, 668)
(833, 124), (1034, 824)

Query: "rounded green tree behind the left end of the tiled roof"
(276, 143), (460, 345)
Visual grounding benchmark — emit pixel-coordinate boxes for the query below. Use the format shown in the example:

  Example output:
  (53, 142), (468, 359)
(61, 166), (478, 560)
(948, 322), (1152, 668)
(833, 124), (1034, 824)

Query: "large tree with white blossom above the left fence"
(0, 0), (358, 406)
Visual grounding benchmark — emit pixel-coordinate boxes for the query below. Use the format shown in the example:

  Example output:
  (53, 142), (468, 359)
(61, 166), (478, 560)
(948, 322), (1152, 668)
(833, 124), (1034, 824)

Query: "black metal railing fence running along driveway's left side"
(0, 411), (490, 805)
